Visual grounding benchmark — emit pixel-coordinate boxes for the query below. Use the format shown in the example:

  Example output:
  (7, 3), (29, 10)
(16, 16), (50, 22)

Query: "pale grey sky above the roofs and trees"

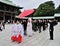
(11, 0), (60, 10)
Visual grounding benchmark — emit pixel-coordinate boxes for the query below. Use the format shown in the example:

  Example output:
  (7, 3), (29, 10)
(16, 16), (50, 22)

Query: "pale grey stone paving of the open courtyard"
(0, 23), (60, 46)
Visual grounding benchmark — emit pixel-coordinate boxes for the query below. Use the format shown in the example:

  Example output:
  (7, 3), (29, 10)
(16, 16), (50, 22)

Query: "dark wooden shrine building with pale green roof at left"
(0, 0), (22, 21)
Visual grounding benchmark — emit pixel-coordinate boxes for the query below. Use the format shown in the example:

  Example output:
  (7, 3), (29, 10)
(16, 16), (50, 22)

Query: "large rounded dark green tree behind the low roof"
(34, 1), (55, 16)
